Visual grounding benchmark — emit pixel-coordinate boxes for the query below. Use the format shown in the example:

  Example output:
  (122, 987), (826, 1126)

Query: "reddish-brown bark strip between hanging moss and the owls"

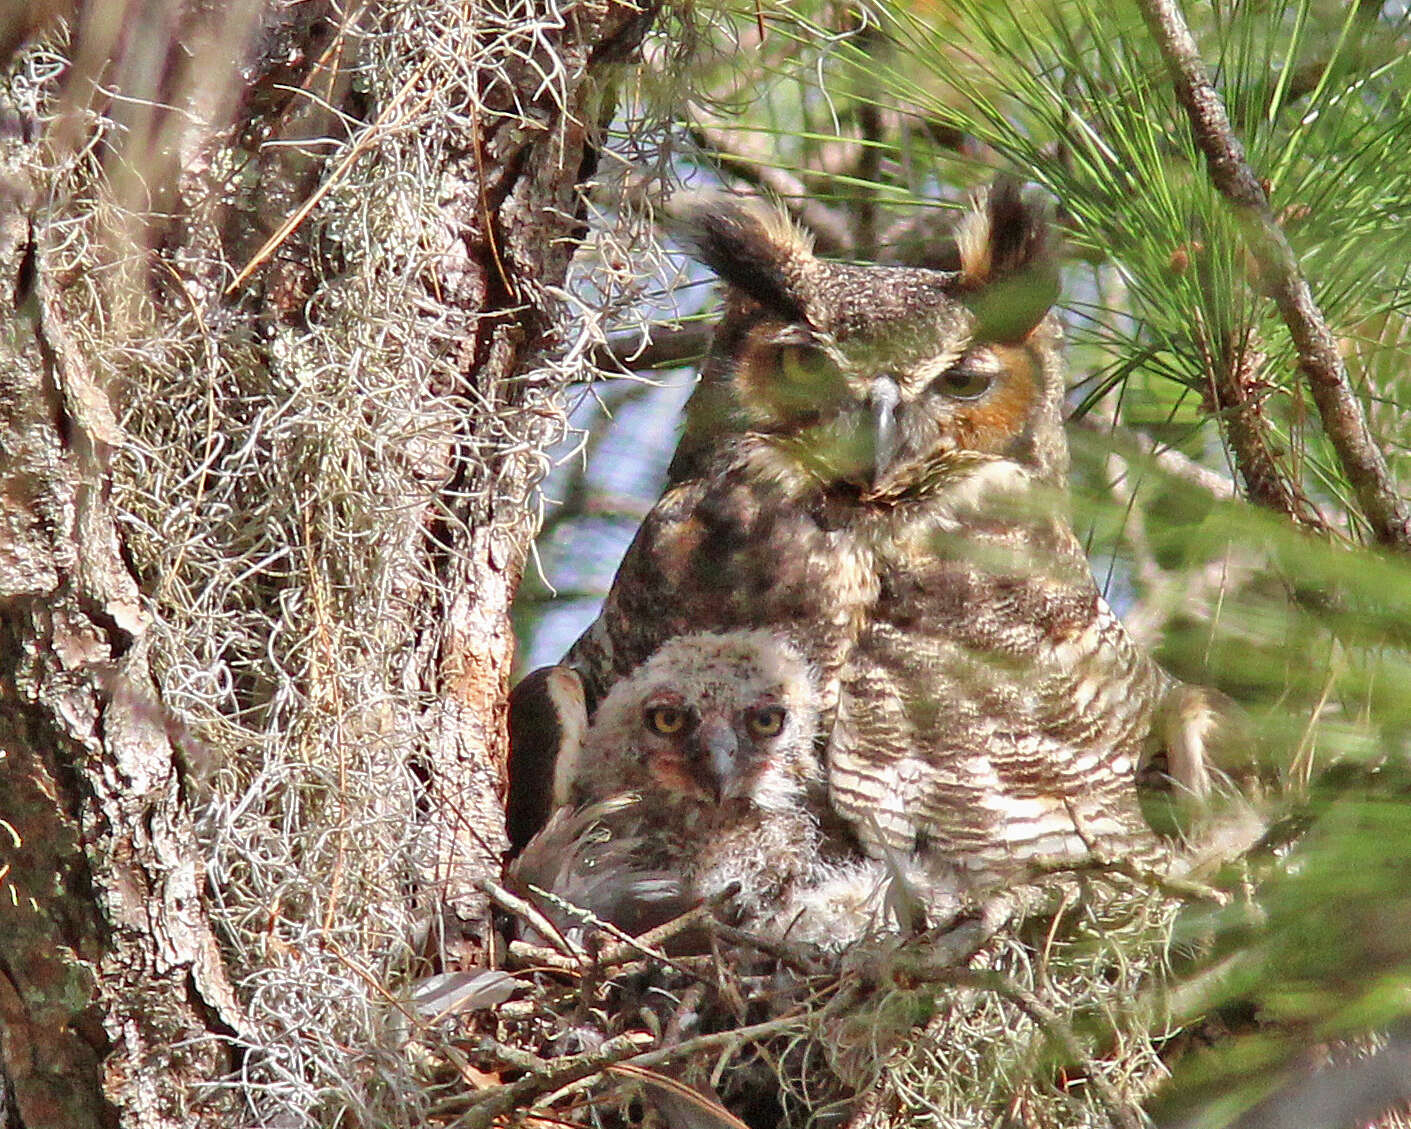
(386, 0), (655, 920)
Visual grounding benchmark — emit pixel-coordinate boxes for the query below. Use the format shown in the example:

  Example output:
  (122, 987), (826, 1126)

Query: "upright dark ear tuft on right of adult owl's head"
(955, 178), (1058, 342)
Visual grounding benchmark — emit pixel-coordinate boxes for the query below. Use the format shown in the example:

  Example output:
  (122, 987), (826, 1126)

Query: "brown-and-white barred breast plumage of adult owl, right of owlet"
(827, 524), (1170, 872)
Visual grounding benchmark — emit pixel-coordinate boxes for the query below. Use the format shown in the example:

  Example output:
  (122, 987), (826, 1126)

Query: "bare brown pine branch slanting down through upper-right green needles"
(1139, 0), (1411, 550)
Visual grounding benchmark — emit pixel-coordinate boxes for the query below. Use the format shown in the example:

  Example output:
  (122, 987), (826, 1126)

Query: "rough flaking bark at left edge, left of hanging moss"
(0, 101), (241, 1126)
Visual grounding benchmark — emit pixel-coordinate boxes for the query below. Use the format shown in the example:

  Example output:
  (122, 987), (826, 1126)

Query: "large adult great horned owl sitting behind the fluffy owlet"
(516, 188), (1236, 897)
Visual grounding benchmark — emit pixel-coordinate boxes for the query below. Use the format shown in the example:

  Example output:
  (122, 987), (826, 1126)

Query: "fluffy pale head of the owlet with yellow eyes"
(573, 631), (820, 811)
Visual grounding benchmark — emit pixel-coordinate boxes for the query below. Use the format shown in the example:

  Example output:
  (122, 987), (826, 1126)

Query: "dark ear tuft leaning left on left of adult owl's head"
(667, 192), (818, 325)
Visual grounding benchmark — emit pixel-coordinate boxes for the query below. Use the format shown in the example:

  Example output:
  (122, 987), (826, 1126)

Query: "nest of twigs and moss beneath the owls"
(415, 871), (1209, 1129)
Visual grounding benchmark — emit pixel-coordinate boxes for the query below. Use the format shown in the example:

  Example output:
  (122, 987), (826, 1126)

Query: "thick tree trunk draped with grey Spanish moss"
(0, 0), (650, 1126)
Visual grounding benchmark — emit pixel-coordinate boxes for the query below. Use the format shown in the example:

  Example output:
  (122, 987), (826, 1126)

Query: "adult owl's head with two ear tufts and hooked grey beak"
(672, 182), (1067, 498)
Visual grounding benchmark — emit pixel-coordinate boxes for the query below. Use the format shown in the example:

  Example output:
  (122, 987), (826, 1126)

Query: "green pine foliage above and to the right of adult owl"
(524, 0), (1411, 1126)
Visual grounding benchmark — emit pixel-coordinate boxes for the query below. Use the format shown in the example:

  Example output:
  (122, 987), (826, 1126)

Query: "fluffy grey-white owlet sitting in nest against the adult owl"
(509, 631), (885, 948)
